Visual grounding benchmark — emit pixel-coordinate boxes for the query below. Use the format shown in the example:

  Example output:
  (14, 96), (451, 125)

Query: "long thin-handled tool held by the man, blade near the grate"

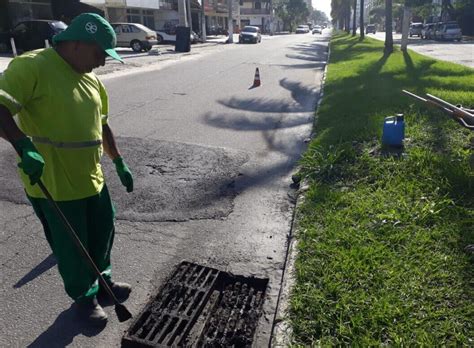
(15, 145), (132, 322)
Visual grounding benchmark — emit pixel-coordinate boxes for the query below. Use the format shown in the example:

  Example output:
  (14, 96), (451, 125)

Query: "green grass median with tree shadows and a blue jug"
(290, 34), (474, 346)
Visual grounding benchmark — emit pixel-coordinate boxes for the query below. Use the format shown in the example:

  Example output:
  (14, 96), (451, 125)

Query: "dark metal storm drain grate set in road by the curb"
(122, 262), (268, 348)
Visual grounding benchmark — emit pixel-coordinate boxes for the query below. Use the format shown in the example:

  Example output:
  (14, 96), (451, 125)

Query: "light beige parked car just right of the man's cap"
(111, 23), (158, 52)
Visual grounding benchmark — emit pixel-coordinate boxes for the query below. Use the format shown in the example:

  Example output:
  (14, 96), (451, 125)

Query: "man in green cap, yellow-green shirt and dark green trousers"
(0, 13), (133, 325)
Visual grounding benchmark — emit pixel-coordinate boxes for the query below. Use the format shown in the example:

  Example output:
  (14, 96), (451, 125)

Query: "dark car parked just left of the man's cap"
(10, 19), (67, 51)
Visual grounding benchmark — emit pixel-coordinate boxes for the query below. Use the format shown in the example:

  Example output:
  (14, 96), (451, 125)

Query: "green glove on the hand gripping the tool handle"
(14, 137), (44, 185)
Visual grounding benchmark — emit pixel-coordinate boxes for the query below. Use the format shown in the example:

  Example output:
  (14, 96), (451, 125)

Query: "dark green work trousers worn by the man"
(28, 185), (115, 302)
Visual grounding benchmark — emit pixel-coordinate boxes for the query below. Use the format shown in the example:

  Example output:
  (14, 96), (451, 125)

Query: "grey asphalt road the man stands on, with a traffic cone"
(0, 34), (328, 347)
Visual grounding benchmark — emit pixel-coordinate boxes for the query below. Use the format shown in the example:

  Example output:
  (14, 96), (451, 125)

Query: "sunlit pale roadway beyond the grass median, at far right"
(368, 32), (474, 68)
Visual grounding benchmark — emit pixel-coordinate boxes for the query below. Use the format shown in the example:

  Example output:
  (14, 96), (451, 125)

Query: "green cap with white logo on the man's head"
(53, 13), (123, 63)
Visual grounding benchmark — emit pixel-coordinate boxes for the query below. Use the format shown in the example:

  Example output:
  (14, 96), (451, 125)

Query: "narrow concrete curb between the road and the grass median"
(269, 36), (331, 347)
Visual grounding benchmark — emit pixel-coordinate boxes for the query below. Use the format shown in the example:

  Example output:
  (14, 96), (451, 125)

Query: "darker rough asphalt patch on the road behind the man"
(0, 137), (249, 221)
